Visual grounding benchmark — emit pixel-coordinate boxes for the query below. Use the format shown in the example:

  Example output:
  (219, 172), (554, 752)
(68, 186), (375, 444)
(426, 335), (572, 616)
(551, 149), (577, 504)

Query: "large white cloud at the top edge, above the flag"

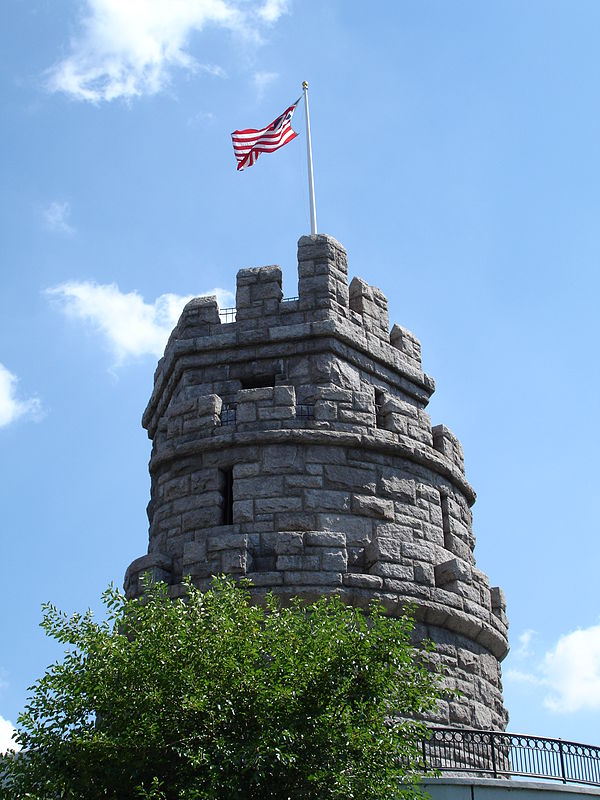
(47, 0), (288, 103)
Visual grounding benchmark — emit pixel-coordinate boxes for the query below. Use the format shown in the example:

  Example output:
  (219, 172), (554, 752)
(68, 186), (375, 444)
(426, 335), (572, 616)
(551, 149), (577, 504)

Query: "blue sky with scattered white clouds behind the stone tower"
(0, 0), (600, 747)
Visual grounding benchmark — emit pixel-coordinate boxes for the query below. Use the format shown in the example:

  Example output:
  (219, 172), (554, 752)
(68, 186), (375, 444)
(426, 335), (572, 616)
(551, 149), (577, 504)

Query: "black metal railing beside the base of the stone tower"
(423, 728), (600, 786)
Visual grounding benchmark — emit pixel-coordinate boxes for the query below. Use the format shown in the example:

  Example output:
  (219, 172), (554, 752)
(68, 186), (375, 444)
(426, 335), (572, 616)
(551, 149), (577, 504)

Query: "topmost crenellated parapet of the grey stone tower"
(143, 234), (435, 436)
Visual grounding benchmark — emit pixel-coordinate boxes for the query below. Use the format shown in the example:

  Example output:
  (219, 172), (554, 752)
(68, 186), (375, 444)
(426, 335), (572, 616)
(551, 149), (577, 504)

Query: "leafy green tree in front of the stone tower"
(0, 578), (441, 800)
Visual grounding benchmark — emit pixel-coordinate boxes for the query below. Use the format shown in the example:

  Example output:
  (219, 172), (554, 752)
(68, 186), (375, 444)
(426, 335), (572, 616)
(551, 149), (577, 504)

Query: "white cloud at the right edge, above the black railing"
(541, 625), (600, 713)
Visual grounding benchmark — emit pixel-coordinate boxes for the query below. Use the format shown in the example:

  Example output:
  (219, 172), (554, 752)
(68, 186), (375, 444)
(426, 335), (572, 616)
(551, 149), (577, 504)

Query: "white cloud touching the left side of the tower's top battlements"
(46, 281), (235, 364)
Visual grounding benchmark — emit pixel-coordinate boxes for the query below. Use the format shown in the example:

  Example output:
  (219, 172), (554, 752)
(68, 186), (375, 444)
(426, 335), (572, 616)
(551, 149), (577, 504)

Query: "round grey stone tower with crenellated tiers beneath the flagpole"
(125, 234), (508, 729)
